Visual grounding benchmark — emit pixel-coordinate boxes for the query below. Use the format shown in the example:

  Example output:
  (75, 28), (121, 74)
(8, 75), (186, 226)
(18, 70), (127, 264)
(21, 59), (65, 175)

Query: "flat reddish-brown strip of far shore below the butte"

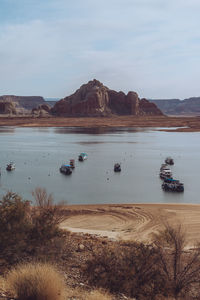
(0, 115), (200, 132)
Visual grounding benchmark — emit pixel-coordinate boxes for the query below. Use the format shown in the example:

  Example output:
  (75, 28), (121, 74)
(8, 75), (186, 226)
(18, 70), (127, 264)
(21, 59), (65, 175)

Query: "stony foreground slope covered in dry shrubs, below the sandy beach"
(0, 188), (200, 300)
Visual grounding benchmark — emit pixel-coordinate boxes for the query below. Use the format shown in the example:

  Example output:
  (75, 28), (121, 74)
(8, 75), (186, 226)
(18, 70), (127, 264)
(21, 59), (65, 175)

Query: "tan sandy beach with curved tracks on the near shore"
(61, 204), (200, 247)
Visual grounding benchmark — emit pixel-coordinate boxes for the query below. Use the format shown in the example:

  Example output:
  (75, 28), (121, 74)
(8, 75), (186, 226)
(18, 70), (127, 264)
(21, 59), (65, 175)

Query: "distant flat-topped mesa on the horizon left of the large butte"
(0, 95), (45, 110)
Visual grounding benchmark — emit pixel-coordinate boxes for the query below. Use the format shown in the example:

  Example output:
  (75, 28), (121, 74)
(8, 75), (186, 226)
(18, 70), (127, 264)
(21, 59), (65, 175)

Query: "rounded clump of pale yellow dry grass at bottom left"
(7, 263), (65, 300)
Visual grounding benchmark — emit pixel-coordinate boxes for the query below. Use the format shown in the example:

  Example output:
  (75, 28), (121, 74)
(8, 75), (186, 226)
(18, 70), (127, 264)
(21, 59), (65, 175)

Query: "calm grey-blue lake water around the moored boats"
(0, 127), (200, 204)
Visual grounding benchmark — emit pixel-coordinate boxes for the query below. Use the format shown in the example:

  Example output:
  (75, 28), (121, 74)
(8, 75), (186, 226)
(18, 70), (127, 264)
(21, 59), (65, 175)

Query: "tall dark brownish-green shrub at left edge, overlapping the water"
(0, 188), (69, 264)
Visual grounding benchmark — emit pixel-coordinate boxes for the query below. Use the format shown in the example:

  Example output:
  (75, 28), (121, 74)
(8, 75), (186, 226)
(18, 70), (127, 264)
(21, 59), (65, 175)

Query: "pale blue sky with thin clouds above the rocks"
(0, 0), (200, 99)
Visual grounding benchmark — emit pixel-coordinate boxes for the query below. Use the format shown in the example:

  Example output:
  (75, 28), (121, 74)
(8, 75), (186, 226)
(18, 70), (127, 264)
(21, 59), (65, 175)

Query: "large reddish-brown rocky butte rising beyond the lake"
(51, 79), (163, 117)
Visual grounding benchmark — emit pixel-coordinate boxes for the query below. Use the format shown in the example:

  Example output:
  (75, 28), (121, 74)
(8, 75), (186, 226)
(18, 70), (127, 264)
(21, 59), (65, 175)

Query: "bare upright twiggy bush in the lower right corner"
(154, 224), (200, 300)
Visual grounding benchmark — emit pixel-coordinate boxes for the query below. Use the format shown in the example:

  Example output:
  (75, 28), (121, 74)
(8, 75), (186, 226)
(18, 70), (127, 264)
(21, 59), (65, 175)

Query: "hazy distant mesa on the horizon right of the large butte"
(149, 97), (200, 115)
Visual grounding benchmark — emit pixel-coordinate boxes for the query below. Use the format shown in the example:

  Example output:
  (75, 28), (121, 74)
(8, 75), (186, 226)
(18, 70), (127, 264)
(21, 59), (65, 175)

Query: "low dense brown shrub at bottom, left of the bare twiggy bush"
(84, 242), (162, 299)
